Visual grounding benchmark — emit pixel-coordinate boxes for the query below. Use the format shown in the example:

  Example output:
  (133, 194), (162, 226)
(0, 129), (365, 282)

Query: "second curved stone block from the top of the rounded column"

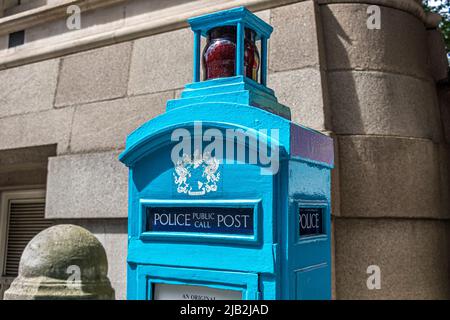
(328, 71), (442, 141)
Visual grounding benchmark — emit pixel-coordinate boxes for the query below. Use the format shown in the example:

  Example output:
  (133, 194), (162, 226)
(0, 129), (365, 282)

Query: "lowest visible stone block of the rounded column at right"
(335, 218), (450, 299)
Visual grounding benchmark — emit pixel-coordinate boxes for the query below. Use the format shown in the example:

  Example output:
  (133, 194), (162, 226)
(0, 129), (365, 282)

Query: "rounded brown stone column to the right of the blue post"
(318, 0), (450, 299)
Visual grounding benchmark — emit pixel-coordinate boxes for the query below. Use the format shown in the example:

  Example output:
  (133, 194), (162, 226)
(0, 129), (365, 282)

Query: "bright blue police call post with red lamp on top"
(120, 7), (334, 300)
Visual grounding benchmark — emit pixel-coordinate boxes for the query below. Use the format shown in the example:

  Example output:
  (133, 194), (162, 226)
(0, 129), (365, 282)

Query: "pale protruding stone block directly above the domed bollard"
(46, 152), (128, 219)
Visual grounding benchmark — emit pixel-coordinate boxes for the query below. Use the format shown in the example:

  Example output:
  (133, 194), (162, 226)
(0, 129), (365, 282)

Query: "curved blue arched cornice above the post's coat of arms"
(119, 102), (290, 167)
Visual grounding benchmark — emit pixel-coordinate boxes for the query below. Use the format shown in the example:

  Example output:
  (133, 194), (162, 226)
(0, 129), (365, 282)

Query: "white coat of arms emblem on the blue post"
(173, 151), (220, 196)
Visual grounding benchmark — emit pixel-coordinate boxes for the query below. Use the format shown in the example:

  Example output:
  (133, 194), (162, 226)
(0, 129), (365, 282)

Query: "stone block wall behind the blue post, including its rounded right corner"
(0, 0), (450, 299)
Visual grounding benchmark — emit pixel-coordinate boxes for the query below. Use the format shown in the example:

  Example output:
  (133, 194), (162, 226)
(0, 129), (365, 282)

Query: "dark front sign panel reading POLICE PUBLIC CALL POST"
(146, 207), (254, 235)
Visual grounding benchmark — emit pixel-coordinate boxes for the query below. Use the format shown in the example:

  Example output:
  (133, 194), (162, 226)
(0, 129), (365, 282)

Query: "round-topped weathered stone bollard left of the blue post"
(4, 224), (115, 300)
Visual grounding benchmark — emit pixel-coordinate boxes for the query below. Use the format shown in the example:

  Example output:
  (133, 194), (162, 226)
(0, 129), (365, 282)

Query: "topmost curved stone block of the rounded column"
(320, 1), (430, 78)
